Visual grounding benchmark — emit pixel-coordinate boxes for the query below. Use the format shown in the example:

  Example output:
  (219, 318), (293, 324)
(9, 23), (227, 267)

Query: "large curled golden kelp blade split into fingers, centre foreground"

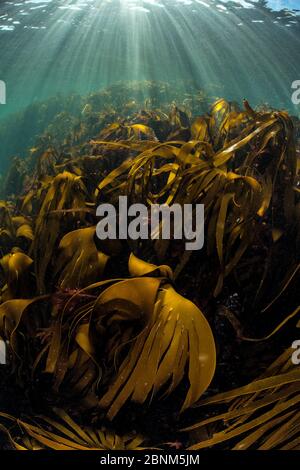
(95, 262), (216, 419)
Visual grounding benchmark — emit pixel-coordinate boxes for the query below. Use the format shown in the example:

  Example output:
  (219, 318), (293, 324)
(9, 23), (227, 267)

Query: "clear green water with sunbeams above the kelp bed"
(0, 0), (300, 172)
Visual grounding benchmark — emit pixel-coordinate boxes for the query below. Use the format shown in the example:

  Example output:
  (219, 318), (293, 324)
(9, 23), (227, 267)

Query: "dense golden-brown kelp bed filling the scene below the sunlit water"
(0, 84), (300, 449)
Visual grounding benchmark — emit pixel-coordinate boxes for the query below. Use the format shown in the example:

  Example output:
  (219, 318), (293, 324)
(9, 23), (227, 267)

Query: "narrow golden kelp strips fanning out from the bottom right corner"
(185, 349), (300, 450)
